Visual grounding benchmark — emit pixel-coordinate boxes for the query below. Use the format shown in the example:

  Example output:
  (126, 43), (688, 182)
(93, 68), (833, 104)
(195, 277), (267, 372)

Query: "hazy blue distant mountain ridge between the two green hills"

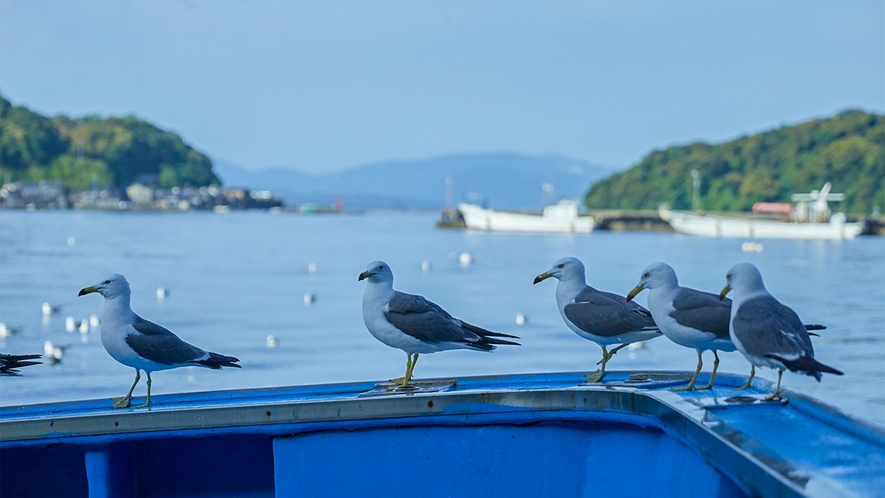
(213, 153), (611, 209)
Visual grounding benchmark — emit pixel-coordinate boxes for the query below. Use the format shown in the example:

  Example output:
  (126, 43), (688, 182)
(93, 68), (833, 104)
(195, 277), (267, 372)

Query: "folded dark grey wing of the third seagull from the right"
(564, 286), (656, 337)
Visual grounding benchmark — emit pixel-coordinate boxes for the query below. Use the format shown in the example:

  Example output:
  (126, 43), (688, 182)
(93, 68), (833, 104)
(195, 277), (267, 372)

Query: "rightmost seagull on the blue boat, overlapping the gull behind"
(719, 263), (842, 401)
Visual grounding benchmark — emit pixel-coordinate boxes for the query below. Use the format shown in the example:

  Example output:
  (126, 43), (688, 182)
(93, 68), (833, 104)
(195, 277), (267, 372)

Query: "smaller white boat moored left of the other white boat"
(458, 200), (595, 233)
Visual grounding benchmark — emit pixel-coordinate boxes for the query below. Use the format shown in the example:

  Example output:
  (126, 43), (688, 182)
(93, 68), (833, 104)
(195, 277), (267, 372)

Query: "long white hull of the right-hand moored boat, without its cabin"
(660, 209), (863, 240)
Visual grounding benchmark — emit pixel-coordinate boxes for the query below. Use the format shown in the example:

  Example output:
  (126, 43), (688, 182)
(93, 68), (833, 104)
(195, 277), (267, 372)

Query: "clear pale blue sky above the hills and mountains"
(0, 0), (885, 173)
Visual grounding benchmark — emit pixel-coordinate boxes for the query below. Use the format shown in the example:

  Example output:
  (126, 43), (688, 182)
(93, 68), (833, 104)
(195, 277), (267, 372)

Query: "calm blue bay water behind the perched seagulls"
(0, 211), (885, 423)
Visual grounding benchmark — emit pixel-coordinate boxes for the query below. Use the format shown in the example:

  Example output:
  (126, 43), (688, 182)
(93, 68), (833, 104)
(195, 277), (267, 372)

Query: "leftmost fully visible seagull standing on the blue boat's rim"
(77, 274), (240, 408)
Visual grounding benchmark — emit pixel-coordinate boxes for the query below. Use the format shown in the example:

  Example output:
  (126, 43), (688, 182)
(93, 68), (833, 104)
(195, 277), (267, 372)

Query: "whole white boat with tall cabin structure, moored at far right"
(659, 183), (863, 240)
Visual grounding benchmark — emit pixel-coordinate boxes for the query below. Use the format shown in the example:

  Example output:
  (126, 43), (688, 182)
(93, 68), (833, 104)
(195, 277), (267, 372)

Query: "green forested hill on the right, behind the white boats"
(584, 111), (885, 213)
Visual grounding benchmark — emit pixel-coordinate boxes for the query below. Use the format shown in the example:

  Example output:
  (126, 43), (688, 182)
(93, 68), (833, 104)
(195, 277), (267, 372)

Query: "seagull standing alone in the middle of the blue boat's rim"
(358, 261), (519, 387)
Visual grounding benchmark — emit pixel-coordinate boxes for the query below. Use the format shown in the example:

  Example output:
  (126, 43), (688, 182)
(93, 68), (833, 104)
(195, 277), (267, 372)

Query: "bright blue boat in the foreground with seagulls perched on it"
(0, 372), (885, 498)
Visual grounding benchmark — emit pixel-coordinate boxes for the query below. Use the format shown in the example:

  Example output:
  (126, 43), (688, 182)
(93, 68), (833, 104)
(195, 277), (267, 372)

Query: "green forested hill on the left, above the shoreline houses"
(0, 96), (220, 190)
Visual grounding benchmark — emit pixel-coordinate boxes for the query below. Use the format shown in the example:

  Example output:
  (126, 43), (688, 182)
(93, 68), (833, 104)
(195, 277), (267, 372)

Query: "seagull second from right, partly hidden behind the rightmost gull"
(627, 263), (740, 391)
